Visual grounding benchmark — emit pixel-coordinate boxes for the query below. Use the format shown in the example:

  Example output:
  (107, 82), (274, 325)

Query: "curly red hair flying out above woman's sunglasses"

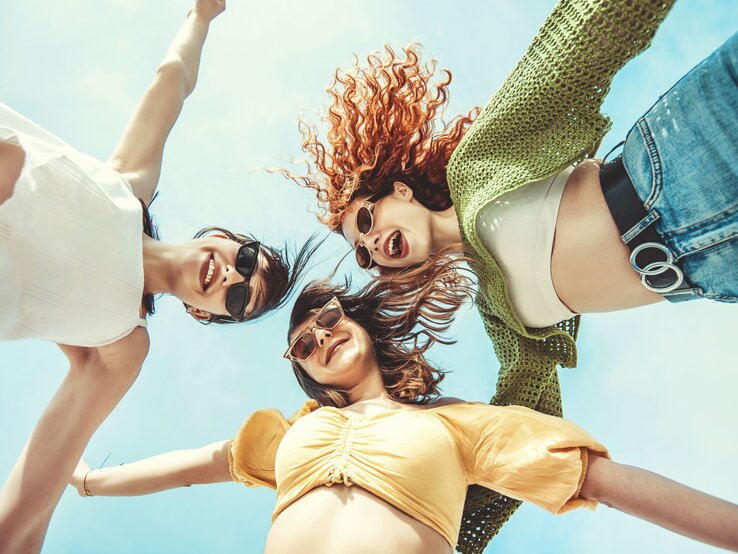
(281, 44), (479, 232)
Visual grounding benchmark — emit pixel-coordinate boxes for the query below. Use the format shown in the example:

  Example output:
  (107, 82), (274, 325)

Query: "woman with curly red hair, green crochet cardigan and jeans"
(290, 0), (738, 420)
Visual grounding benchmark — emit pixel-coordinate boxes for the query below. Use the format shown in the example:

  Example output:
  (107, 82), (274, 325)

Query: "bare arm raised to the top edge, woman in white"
(107, 0), (225, 204)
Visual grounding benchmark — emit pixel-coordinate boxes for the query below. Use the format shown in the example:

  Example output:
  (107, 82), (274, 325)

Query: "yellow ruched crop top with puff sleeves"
(229, 400), (608, 546)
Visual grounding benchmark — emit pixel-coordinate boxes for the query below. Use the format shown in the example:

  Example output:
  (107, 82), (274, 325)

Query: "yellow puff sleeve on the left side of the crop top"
(228, 400), (318, 489)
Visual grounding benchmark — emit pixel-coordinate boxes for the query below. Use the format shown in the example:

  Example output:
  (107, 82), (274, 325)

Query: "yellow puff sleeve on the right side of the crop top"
(440, 403), (609, 514)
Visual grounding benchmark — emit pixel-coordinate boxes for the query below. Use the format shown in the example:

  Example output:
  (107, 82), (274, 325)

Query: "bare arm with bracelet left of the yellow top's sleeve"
(70, 441), (232, 496)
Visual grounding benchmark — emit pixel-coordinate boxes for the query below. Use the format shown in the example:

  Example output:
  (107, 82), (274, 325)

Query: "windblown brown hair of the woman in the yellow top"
(287, 256), (474, 408)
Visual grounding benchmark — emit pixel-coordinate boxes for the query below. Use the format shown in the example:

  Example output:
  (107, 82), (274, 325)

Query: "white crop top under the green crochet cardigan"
(476, 167), (577, 327)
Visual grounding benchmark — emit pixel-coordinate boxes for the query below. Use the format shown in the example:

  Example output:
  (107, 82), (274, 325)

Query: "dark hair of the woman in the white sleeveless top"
(185, 227), (325, 324)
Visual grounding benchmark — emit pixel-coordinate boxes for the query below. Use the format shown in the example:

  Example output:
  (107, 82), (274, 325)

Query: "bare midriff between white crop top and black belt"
(551, 160), (663, 313)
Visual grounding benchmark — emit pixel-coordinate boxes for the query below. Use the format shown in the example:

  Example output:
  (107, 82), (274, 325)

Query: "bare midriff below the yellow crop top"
(264, 485), (452, 554)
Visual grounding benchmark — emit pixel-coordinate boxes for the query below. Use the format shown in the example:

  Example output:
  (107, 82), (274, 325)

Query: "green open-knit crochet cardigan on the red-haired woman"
(447, 0), (673, 553)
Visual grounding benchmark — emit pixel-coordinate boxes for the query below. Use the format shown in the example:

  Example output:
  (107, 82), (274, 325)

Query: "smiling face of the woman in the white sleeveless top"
(172, 236), (266, 318)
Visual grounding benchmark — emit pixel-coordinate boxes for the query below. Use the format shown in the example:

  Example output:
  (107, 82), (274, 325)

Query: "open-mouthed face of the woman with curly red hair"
(341, 182), (432, 267)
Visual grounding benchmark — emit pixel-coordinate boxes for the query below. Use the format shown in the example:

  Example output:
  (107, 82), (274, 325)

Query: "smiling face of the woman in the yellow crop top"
(289, 302), (378, 390)
